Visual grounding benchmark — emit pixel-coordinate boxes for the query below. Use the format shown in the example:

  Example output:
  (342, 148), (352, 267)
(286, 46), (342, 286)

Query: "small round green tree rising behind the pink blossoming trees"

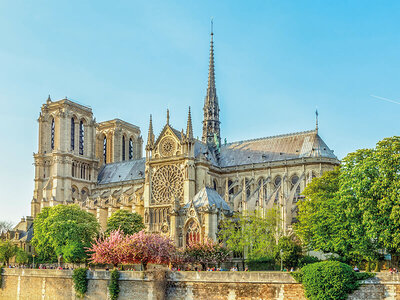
(106, 210), (144, 235)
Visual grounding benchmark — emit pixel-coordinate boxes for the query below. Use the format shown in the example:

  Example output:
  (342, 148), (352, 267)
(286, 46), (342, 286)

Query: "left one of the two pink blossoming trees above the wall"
(88, 230), (127, 267)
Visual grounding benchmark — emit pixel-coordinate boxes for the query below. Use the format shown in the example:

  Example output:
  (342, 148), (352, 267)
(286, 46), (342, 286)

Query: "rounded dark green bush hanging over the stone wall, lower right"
(291, 261), (374, 300)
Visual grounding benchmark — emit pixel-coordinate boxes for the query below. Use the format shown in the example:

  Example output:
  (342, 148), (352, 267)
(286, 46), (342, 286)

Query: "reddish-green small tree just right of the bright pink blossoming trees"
(185, 239), (230, 270)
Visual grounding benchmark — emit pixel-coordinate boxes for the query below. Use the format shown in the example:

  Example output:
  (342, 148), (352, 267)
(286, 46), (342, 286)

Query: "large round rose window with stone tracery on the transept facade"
(152, 165), (183, 203)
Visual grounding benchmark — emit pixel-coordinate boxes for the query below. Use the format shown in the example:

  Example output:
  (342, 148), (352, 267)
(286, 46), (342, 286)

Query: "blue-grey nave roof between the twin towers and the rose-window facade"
(97, 158), (145, 184)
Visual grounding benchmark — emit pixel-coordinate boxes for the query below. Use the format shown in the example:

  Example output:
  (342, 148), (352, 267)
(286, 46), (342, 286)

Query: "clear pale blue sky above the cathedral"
(0, 0), (400, 223)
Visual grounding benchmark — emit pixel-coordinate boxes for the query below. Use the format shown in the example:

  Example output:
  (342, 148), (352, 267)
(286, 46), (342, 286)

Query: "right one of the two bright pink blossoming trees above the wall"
(126, 230), (176, 270)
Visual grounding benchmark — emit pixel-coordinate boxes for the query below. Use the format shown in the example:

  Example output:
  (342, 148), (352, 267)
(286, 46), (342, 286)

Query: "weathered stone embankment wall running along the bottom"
(0, 269), (400, 300)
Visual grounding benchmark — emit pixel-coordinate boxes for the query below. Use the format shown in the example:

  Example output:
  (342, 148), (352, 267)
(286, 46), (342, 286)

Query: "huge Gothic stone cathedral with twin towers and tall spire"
(12, 28), (339, 247)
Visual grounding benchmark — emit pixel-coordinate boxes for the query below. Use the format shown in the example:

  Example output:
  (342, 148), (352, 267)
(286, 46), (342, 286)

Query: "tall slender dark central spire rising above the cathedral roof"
(202, 20), (221, 145)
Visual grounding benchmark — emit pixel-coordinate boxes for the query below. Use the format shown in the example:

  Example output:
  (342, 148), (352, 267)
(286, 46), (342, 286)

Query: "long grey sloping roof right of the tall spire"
(218, 130), (337, 167)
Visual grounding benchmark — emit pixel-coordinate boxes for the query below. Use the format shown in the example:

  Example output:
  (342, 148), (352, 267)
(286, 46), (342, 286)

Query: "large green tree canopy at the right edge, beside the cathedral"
(295, 137), (400, 260)
